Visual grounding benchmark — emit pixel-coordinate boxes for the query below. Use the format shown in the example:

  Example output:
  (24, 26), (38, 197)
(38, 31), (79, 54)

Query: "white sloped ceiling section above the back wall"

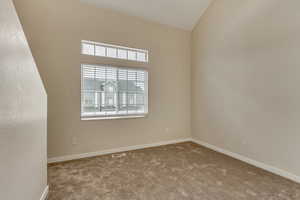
(81, 0), (212, 30)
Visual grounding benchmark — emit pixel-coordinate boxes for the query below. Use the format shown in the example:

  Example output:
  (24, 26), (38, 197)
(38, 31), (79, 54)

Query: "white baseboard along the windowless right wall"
(192, 139), (300, 183)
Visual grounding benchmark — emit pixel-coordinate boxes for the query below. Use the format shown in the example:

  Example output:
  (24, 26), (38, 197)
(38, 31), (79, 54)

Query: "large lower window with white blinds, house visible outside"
(81, 64), (148, 119)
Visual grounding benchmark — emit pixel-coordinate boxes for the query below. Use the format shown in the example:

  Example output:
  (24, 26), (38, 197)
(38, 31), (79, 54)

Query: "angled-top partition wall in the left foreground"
(0, 0), (47, 200)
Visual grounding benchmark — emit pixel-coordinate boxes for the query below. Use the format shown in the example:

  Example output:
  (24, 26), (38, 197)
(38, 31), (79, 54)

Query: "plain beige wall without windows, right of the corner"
(192, 0), (300, 176)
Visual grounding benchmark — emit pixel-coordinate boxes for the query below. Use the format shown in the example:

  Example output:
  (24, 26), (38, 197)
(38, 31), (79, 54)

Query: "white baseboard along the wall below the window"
(48, 138), (192, 164)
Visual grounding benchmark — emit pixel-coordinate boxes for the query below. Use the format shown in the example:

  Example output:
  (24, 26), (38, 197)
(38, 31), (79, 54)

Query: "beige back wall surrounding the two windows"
(15, 0), (190, 157)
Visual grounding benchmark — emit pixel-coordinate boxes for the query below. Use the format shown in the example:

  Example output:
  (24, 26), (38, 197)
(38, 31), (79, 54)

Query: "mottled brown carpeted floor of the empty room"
(48, 143), (300, 200)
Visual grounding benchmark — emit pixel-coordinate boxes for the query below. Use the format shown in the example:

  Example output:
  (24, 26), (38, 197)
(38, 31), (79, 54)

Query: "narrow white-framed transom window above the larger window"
(81, 40), (149, 62)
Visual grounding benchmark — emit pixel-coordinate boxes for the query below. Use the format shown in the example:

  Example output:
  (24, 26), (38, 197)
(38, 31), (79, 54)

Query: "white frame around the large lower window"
(80, 63), (149, 121)
